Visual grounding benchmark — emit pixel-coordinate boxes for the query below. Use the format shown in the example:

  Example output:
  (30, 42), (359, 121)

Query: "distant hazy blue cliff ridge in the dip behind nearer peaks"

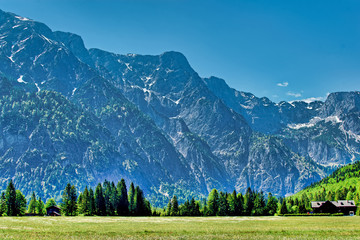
(204, 77), (323, 134)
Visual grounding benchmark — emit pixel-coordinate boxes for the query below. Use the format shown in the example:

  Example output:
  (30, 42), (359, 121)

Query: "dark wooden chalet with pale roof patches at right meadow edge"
(311, 200), (356, 215)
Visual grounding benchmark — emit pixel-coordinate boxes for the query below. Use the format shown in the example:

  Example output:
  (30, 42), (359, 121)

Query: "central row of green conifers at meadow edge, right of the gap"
(162, 188), (278, 216)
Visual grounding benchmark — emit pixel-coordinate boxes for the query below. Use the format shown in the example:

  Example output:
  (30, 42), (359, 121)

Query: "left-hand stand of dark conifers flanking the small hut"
(0, 179), (152, 216)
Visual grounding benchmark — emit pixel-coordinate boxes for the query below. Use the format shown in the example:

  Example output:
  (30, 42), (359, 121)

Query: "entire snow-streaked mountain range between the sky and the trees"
(0, 10), (360, 204)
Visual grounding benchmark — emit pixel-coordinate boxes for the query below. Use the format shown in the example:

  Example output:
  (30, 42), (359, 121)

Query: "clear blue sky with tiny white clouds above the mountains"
(0, 0), (360, 102)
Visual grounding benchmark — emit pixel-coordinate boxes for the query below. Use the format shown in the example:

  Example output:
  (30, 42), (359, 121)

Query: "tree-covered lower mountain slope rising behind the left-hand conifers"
(0, 86), (129, 198)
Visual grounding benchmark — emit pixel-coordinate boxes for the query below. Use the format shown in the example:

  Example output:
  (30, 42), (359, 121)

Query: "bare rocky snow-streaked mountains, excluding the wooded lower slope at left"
(0, 8), (360, 201)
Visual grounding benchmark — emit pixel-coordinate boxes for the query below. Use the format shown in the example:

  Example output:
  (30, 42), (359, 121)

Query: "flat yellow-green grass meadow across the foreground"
(0, 217), (360, 239)
